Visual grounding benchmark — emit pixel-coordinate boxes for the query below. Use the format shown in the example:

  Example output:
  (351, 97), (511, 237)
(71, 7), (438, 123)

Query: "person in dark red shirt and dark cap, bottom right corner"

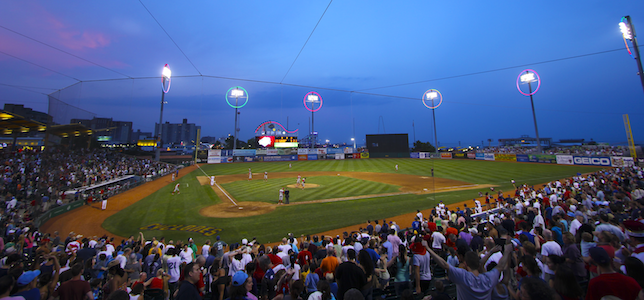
(586, 247), (642, 300)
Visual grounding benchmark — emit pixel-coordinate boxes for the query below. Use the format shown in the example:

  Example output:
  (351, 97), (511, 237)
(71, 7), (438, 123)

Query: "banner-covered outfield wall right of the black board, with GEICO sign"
(410, 152), (635, 167)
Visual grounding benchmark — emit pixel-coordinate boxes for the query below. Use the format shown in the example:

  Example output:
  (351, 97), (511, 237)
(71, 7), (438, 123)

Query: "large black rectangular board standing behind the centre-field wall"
(367, 133), (409, 158)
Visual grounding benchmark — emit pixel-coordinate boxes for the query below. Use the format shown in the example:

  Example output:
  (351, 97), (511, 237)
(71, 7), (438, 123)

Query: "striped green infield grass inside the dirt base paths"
(222, 173), (400, 203)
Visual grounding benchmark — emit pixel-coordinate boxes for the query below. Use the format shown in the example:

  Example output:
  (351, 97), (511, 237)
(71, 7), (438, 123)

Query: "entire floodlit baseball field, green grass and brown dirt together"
(43, 159), (600, 243)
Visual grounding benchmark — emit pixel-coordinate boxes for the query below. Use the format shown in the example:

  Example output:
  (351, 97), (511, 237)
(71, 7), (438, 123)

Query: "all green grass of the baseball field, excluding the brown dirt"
(103, 159), (600, 243)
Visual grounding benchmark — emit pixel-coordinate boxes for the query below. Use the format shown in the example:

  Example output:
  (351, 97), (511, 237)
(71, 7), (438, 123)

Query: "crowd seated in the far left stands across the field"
(0, 149), (176, 218)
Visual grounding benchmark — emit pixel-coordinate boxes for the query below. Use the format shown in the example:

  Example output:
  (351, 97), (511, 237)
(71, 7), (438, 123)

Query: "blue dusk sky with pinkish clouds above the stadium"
(0, 0), (644, 146)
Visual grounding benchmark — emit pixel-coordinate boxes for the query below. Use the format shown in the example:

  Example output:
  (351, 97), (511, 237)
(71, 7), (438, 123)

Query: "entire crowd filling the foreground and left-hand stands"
(0, 152), (644, 300)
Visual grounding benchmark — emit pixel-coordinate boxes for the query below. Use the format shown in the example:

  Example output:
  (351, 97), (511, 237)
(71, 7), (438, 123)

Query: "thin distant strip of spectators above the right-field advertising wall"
(477, 145), (630, 156)
